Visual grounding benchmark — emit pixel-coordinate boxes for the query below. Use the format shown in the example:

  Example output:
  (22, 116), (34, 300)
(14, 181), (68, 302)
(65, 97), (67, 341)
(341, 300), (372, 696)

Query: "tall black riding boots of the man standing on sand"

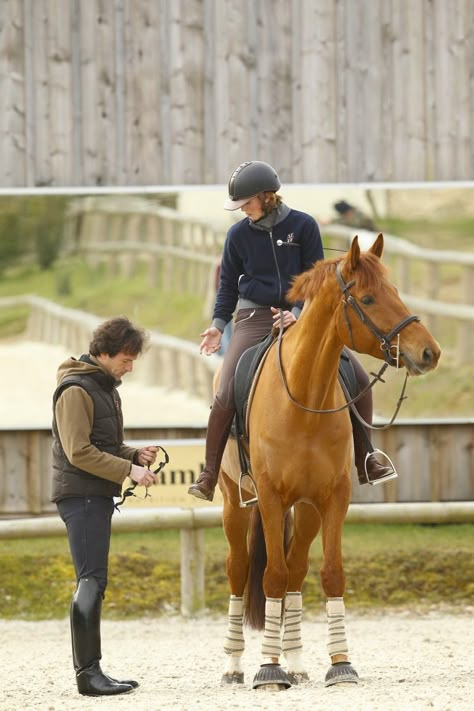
(70, 578), (136, 696)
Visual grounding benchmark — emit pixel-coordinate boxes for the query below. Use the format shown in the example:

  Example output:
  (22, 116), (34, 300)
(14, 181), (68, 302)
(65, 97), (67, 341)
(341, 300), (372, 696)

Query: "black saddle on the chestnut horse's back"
(231, 332), (358, 474)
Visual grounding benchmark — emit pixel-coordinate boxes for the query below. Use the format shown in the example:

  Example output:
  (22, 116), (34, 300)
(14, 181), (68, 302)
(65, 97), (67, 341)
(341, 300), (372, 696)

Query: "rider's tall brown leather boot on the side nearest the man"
(188, 398), (235, 501)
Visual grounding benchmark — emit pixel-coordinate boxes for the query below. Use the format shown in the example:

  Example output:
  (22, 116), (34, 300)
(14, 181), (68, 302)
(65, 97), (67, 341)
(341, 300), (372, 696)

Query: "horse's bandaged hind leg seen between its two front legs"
(282, 503), (321, 684)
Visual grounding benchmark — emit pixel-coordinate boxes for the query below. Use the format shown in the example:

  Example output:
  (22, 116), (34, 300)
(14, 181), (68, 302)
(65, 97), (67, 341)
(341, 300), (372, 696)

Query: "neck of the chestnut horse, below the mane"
(283, 299), (343, 408)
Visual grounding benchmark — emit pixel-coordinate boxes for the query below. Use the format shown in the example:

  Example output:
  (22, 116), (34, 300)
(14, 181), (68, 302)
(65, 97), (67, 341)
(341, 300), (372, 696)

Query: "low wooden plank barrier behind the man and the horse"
(0, 420), (474, 518)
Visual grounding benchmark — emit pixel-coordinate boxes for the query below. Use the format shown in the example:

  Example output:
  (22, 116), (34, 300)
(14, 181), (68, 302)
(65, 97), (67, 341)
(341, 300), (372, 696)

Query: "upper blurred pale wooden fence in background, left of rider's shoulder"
(65, 196), (226, 303)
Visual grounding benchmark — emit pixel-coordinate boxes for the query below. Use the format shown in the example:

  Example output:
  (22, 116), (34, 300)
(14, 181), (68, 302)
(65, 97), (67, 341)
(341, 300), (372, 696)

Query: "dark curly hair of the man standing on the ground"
(89, 316), (147, 358)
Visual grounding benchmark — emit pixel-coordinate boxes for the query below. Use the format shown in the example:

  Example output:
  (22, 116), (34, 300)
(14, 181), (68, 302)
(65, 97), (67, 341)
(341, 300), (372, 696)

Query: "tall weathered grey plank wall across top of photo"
(0, 0), (474, 187)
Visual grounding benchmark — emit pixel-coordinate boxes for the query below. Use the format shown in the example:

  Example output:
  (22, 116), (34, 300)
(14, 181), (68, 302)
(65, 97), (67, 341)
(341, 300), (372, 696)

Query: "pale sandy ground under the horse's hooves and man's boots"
(0, 608), (474, 711)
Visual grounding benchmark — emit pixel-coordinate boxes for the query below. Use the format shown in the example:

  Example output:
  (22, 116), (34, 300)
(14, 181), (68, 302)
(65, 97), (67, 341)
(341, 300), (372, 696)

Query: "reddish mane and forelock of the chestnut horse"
(287, 252), (387, 303)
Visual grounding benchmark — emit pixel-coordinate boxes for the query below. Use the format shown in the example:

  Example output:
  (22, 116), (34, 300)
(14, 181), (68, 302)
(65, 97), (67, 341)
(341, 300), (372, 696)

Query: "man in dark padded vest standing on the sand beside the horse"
(52, 317), (158, 696)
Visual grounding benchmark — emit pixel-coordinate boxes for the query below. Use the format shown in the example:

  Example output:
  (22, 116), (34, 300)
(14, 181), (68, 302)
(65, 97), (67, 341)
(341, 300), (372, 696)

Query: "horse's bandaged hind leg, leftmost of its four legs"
(221, 473), (251, 684)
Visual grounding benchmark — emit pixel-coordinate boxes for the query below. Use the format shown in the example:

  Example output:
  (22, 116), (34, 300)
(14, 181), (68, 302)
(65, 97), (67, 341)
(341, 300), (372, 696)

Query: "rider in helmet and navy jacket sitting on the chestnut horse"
(188, 160), (396, 501)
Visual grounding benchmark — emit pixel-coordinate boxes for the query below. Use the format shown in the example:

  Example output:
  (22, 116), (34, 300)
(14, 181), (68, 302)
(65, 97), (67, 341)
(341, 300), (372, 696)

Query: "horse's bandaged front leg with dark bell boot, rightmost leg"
(321, 487), (359, 686)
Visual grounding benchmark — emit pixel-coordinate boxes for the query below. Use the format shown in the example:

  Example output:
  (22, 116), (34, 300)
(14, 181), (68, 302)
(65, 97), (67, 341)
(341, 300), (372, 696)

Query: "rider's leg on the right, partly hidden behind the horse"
(347, 351), (397, 484)
